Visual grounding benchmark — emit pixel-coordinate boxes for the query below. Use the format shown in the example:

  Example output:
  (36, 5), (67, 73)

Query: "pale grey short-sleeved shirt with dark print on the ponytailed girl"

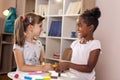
(13, 40), (43, 65)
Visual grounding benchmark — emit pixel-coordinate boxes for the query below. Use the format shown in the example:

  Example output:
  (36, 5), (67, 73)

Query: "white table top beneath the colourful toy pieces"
(7, 71), (79, 80)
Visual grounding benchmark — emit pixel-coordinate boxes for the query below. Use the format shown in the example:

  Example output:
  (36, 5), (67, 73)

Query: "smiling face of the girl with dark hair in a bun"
(77, 17), (91, 38)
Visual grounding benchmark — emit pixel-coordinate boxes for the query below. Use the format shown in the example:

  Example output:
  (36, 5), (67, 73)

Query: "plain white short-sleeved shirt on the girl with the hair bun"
(70, 40), (101, 80)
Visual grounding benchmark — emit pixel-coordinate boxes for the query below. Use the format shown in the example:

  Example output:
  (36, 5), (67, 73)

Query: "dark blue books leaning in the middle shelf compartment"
(48, 21), (62, 37)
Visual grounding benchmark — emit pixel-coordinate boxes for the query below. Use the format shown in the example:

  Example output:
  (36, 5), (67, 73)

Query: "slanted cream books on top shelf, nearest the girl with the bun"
(66, 1), (82, 14)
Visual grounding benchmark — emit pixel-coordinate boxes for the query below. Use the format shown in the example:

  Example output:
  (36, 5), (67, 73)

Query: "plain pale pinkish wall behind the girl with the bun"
(95, 0), (120, 80)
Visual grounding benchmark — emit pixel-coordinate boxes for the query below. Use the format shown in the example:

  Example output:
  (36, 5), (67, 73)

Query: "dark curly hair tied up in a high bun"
(80, 7), (101, 31)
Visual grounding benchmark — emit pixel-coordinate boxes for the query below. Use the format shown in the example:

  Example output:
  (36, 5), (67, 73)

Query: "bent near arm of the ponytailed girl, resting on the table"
(14, 49), (44, 72)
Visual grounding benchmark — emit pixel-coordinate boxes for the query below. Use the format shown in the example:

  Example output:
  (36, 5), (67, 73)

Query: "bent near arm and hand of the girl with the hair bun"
(58, 49), (100, 73)
